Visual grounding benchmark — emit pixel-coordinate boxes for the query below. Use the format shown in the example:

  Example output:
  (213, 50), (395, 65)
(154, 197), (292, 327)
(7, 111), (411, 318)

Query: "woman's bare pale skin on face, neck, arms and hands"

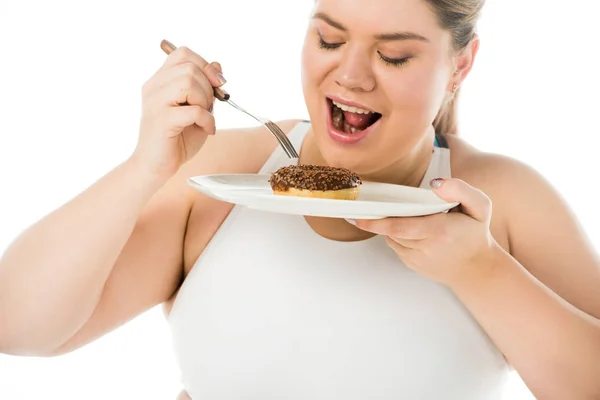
(0, 0), (600, 399)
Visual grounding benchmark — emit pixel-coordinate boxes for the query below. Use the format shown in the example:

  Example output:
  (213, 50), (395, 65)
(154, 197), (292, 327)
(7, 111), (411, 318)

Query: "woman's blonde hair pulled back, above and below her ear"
(426, 0), (485, 135)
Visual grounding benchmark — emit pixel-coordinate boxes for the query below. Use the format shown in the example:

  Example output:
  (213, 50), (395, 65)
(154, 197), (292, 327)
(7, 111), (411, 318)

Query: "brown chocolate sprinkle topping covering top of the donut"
(269, 165), (362, 192)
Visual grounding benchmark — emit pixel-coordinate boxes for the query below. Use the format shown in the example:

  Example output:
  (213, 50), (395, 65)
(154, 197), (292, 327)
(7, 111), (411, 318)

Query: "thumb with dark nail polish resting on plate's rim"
(429, 178), (492, 223)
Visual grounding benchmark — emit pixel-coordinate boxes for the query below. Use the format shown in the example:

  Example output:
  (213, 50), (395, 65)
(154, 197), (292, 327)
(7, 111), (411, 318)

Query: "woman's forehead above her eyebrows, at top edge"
(314, 0), (443, 40)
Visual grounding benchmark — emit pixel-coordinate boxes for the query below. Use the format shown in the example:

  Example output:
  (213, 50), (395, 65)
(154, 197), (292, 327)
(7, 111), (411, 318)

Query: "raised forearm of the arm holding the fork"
(0, 161), (163, 352)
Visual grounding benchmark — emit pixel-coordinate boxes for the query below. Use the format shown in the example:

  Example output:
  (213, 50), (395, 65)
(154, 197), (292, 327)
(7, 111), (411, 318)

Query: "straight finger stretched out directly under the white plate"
(356, 217), (429, 240)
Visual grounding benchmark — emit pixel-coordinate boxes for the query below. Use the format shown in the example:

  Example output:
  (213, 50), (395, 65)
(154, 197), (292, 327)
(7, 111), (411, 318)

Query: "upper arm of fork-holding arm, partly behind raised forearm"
(54, 158), (199, 355)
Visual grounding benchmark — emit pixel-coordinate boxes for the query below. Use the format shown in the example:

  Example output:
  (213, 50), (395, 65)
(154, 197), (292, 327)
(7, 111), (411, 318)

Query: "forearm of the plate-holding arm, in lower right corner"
(452, 247), (600, 399)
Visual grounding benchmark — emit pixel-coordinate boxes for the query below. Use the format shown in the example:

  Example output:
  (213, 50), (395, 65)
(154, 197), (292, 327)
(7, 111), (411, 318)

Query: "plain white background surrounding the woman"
(0, 0), (600, 400)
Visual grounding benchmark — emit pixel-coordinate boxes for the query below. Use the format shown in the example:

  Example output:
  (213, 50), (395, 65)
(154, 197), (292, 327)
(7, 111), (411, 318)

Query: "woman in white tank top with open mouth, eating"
(0, 0), (600, 399)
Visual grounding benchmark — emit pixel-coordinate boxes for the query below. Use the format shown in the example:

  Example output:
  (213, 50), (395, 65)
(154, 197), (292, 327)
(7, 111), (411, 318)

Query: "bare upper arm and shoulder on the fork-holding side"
(56, 120), (297, 354)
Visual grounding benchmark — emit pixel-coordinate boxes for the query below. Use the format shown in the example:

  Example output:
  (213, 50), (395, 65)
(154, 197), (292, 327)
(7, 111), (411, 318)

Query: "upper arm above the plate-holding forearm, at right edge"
(466, 155), (600, 318)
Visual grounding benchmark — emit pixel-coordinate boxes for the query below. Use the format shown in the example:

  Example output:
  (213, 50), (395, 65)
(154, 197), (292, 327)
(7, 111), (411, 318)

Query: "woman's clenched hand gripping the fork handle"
(130, 39), (224, 181)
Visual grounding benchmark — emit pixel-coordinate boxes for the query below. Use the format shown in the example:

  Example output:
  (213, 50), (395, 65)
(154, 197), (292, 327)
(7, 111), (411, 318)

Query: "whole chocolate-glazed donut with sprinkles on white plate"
(269, 165), (362, 200)
